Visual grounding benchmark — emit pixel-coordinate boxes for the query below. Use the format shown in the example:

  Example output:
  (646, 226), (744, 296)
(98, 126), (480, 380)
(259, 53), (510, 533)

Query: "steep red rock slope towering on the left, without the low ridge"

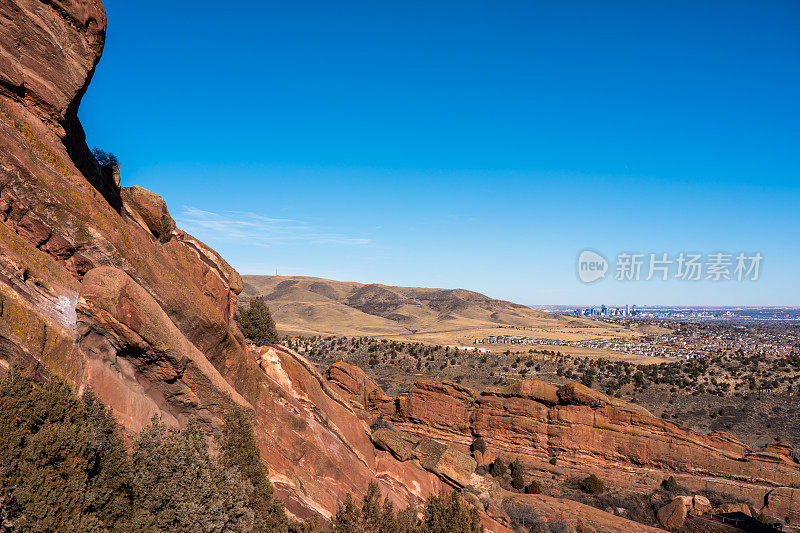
(0, 0), (476, 517)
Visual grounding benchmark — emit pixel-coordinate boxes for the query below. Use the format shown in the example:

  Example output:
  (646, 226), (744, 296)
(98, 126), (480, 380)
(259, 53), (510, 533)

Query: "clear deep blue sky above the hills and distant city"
(80, 0), (800, 305)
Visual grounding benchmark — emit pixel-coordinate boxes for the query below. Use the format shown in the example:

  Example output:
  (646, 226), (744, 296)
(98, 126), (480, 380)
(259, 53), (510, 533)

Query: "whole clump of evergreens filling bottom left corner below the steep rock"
(0, 369), (310, 533)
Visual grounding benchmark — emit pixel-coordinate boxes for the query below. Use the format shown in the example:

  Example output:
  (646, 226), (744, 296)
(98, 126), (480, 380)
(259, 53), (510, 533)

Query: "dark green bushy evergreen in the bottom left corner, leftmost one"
(0, 369), (130, 531)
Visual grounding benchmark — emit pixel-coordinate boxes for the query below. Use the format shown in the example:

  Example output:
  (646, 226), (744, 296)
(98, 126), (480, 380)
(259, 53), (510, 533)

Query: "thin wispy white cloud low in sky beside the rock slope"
(175, 206), (371, 247)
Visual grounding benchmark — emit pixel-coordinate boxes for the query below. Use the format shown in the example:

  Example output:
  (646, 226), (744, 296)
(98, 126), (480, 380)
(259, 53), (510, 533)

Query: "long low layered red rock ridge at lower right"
(376, 380), (800, 519)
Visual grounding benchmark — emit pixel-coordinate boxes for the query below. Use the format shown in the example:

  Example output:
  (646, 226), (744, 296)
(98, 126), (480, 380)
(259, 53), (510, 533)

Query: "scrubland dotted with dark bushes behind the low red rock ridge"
(292, 324), (800, 446)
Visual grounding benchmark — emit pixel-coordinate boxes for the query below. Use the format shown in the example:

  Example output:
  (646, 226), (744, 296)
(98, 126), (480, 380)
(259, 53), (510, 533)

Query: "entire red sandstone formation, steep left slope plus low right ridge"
(0, 0), (800, 531)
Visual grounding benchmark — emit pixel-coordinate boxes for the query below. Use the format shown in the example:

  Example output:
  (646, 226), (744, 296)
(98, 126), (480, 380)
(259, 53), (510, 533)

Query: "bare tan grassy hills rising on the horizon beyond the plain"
(240, 275), (569, 335)
